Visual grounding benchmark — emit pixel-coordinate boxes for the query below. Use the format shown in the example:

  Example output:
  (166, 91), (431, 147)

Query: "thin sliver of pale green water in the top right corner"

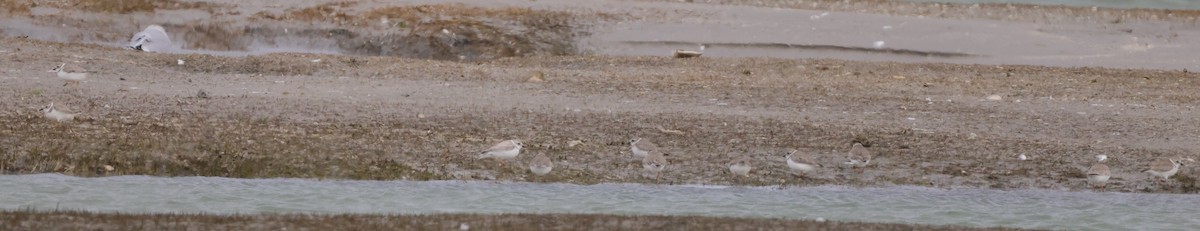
(907, 0), (1200, 10)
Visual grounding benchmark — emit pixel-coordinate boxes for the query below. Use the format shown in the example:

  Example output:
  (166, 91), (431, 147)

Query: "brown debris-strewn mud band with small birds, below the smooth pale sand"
(0, 35), (1198, 193)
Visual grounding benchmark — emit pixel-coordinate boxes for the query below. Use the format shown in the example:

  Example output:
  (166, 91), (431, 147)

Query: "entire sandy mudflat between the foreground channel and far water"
(0, 0), (1200, 228)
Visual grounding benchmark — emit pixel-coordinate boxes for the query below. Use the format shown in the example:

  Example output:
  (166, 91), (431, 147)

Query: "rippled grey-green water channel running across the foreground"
(0, 174), (1200, 230)
